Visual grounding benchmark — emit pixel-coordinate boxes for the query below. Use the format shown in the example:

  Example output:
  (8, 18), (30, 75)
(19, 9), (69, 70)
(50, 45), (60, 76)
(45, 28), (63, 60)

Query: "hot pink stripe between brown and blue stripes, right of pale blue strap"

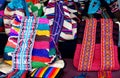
(34, 41), (49, 49)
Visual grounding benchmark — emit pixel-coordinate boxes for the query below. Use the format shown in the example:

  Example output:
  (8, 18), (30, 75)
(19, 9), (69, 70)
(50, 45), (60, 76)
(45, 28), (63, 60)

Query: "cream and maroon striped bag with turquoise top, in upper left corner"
(3, 0), (25, 34)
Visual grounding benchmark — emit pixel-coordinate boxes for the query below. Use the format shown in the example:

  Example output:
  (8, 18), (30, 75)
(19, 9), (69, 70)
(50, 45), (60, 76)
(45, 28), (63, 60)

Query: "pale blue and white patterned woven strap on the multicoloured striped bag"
(12, 17), (37, 70)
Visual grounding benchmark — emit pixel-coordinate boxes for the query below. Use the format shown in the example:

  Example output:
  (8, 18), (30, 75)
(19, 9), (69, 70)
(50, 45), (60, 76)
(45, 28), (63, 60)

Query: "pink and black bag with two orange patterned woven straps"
(73, 18), (120, 78)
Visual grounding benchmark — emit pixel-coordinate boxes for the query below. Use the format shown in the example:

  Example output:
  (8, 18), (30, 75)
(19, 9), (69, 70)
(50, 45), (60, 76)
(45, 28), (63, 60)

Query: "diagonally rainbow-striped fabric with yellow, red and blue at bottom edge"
(31, 67), (61, 78)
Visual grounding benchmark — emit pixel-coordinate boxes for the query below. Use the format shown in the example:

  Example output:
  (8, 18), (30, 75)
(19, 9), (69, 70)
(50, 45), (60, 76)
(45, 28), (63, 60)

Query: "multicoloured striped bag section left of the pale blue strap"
(4, 16), (22, 65)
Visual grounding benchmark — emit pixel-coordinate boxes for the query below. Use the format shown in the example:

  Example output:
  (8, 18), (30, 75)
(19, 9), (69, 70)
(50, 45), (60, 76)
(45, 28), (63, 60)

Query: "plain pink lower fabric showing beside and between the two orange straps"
(73, 44), (120, 71)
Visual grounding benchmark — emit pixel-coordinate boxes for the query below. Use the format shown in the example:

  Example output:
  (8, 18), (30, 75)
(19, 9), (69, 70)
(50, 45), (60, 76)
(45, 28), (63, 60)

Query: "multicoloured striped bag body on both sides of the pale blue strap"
(4, 17), (55, 68)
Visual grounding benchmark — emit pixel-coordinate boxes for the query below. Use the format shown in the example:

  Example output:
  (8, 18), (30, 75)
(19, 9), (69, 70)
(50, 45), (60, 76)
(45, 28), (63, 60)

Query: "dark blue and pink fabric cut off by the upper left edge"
(0, 0), (6, 32)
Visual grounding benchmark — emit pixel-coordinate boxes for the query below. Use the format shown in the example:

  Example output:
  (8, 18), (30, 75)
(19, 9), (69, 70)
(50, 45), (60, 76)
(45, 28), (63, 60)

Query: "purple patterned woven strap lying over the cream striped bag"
(52, 1), (64, 43)
